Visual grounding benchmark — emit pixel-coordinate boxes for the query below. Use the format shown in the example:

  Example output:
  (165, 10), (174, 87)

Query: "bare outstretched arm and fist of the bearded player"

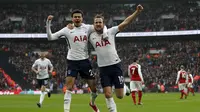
(118, 5), (143, 31)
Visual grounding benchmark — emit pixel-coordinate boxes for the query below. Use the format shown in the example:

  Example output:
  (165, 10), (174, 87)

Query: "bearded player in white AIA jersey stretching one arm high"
(89, 5), (143, 112)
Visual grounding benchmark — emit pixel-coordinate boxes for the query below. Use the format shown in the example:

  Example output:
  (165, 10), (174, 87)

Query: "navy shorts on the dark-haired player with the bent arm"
(66, 59), (95, 79)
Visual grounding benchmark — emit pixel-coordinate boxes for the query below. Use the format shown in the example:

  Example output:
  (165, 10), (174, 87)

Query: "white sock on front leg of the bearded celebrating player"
(106, 98), (117, 112)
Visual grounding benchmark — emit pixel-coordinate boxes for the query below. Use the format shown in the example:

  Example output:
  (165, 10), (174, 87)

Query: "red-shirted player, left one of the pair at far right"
(176, 65), (188, 99)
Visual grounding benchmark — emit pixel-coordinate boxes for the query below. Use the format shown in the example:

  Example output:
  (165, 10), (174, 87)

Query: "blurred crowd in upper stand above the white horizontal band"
(0, 1), (200, 33)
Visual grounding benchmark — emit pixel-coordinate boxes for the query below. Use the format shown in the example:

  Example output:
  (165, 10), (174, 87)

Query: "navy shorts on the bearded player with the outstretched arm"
(100, 63), (124, 89)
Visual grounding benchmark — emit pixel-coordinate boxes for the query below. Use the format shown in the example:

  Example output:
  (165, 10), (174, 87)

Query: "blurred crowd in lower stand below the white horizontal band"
(0, 38), (200, 92)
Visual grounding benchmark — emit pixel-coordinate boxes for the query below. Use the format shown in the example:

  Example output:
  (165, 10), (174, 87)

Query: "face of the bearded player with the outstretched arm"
(94, 18), (104, 32)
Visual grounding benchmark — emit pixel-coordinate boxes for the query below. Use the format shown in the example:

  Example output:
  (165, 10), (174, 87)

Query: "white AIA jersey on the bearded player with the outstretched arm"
(89, 26), (121, 67)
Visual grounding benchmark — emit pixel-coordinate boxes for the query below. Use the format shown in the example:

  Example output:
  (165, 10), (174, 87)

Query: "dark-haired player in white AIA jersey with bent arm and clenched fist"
(47, 10), (107, 112)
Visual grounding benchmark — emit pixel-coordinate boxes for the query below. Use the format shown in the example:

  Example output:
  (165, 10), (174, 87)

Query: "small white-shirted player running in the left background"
(32, 52), (53, 108)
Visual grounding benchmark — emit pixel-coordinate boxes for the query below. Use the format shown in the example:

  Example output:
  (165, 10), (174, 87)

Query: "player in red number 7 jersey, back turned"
(128, 58), (144, 105)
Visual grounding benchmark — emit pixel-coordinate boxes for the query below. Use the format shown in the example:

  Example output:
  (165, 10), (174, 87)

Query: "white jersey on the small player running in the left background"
(32, 58), (53, 79)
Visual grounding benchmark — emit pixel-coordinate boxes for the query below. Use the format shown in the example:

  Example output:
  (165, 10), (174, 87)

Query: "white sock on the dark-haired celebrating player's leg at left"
(64, 90), (72, 112)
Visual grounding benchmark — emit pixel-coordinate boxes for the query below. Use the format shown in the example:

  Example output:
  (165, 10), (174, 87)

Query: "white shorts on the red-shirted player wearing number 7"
(130, 81), (142, 92)
